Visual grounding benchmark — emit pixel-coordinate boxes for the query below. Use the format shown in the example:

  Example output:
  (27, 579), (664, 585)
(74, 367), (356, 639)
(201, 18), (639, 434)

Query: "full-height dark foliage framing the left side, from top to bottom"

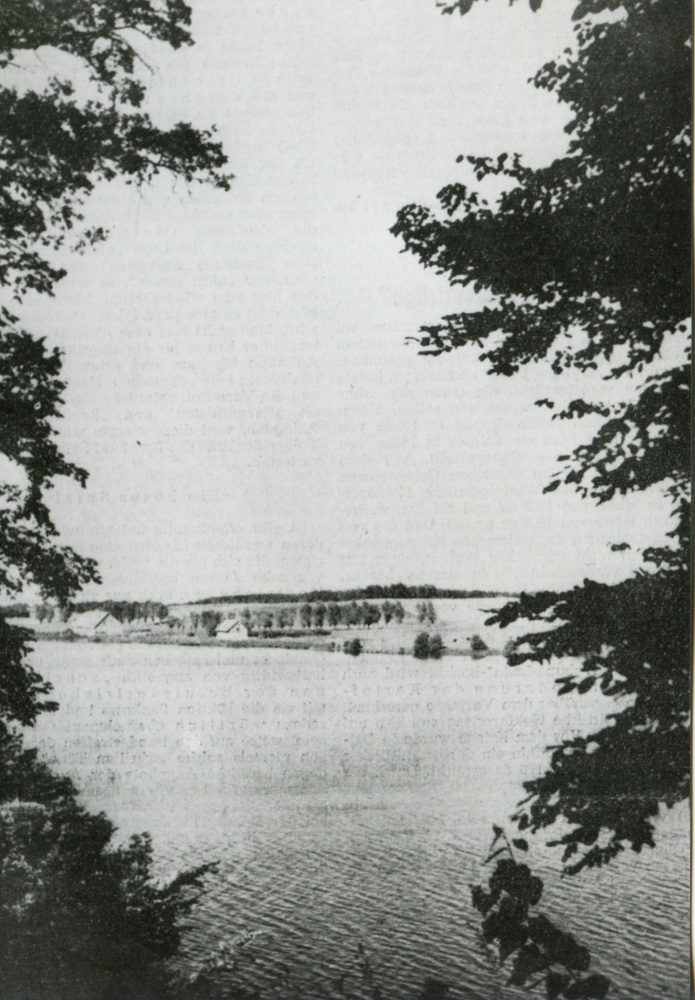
(0, 0), (234, 1000)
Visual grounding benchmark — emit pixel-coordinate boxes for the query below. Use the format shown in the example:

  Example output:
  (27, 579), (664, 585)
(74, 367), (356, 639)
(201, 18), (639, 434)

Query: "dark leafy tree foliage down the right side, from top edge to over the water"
(392, 0), (692, 873)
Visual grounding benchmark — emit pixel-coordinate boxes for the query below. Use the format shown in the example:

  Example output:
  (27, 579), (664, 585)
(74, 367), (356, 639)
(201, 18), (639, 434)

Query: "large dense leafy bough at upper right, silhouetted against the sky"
(393, 0), (692, 375)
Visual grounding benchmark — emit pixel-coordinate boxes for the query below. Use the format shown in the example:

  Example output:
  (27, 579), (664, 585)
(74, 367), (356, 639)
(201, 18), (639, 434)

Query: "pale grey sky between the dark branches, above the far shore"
(10, 0), (675, 603)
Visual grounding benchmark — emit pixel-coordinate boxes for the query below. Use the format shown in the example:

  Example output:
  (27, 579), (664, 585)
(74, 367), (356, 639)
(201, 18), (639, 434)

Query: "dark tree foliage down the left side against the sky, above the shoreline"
(0, 0), (234, 603)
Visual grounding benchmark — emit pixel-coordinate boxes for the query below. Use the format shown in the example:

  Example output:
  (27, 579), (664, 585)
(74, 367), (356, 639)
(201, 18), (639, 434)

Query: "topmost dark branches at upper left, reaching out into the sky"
(0, 0), (230, 298)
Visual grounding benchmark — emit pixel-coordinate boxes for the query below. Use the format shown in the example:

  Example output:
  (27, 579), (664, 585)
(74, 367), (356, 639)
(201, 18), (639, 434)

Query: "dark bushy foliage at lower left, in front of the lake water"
(0, 621), (214, 1000)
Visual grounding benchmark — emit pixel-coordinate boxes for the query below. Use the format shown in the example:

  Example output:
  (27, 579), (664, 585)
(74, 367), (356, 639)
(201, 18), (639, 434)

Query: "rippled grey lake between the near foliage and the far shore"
(28, 642), (690, 1000)
